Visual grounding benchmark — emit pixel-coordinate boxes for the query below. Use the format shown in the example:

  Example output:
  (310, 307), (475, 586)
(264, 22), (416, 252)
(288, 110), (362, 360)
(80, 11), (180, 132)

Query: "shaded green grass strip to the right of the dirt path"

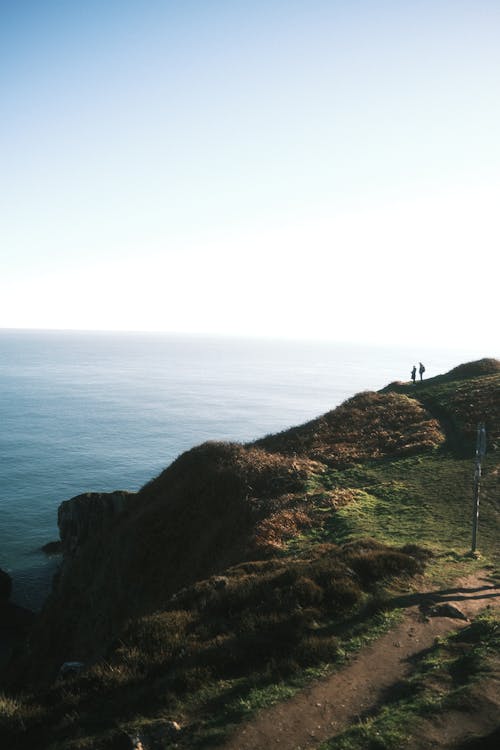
(320, 612), (500, 750)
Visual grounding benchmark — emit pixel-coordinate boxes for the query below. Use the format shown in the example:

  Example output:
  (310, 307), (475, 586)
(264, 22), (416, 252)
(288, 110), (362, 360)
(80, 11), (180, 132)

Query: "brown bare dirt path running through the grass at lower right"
(219, 573), (500, 750)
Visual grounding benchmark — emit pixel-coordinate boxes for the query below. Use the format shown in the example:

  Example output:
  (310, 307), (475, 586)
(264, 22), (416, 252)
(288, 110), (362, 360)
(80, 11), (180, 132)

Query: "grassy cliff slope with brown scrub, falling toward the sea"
(0, 360), (500, 750)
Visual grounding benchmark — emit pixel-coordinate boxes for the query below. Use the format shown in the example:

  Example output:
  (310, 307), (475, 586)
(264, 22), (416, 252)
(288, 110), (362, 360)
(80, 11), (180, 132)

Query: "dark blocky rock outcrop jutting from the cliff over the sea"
(57, 490), (135, 558)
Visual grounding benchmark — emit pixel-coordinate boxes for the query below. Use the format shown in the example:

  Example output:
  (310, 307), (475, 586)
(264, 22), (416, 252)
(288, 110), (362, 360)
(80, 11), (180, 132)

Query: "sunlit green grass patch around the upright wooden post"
(289, 451), (500, 580)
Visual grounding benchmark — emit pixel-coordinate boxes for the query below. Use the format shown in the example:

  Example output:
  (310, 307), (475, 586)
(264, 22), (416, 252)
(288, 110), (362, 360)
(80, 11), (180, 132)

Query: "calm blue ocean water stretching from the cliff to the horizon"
(0, 330), (495, 607)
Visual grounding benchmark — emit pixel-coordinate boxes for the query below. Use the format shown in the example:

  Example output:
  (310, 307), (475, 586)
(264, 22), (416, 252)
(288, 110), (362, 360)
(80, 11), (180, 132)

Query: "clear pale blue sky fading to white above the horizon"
(0, 0), (500, 354)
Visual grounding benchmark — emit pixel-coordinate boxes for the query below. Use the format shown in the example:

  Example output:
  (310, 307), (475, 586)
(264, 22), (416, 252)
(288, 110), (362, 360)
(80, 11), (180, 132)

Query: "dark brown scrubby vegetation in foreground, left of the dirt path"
(0, 539), (424, 750)
